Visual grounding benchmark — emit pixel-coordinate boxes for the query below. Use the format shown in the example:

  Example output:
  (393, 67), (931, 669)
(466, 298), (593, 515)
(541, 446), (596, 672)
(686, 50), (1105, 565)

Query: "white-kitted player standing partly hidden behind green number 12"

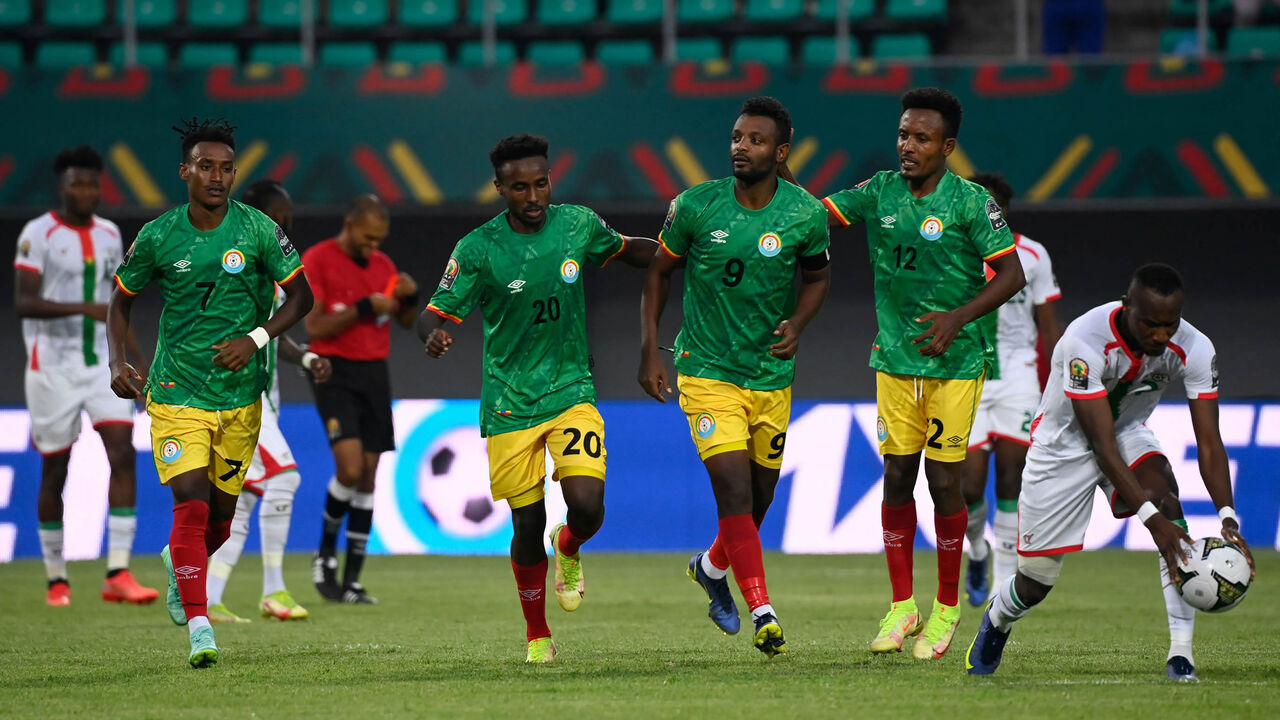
(964, 173), (1062, 607)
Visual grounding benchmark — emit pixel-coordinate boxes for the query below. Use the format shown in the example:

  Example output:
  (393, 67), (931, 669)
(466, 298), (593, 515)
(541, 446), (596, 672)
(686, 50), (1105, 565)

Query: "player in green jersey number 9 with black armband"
(637, 97), (831, 657)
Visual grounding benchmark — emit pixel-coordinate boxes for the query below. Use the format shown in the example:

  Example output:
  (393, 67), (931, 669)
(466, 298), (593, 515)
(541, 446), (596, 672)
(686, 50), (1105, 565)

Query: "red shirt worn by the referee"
(302, 237), (397, 360)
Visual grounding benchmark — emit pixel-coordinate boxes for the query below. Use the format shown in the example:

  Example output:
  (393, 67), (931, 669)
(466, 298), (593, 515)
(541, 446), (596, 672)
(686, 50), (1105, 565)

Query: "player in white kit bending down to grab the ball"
(966, 264), (1253, 682)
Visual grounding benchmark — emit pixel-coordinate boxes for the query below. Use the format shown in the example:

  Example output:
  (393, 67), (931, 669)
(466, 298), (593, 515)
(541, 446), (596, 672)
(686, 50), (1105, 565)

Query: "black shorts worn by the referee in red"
(307, 356), (396, 452)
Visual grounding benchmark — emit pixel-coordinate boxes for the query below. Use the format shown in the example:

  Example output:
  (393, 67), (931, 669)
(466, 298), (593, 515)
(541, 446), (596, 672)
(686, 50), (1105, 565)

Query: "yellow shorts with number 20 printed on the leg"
(489, 402), (608, 509)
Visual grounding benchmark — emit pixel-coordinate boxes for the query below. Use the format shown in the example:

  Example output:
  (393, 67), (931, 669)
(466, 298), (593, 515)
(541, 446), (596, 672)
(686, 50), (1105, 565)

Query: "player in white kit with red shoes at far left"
(13, 145), (159, 606)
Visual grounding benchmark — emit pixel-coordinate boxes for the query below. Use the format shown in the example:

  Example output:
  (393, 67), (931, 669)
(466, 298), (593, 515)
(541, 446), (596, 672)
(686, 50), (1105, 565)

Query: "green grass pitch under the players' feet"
(0, 551), (1280, 720)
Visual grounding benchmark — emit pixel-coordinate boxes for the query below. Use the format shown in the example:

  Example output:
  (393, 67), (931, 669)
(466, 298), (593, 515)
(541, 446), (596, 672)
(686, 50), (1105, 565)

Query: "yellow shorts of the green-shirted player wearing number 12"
(876, 370), (983, 462)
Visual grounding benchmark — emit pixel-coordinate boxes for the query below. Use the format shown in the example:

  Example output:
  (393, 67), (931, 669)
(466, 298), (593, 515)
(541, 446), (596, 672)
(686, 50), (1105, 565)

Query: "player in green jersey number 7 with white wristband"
(106, 119), (311, 667)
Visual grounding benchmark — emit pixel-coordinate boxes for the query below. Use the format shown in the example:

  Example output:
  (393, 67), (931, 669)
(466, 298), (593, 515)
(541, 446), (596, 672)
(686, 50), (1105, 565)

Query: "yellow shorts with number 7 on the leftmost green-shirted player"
(147, 397), (262, 495)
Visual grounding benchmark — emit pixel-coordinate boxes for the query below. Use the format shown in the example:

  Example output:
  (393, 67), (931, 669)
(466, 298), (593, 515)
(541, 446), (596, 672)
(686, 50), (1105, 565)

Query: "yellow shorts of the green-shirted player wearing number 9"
(676, 374), (791, 469)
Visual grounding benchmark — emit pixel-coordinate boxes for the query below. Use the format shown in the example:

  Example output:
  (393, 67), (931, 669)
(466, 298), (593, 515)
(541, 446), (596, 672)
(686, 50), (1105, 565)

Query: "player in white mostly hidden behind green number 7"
(206, 179), (332, 623)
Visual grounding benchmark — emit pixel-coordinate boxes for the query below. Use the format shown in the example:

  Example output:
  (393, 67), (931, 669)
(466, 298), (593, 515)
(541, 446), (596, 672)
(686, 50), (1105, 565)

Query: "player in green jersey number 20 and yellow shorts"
(417, 135), (657, 662)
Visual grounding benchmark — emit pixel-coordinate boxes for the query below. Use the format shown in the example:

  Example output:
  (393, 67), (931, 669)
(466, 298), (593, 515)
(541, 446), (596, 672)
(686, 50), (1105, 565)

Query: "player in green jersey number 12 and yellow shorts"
(823, 87), (1024, 660)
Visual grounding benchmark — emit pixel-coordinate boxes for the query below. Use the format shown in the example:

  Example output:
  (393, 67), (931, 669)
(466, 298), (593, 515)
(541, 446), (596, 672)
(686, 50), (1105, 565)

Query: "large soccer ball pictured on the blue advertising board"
(417, 427), (511, 538)
